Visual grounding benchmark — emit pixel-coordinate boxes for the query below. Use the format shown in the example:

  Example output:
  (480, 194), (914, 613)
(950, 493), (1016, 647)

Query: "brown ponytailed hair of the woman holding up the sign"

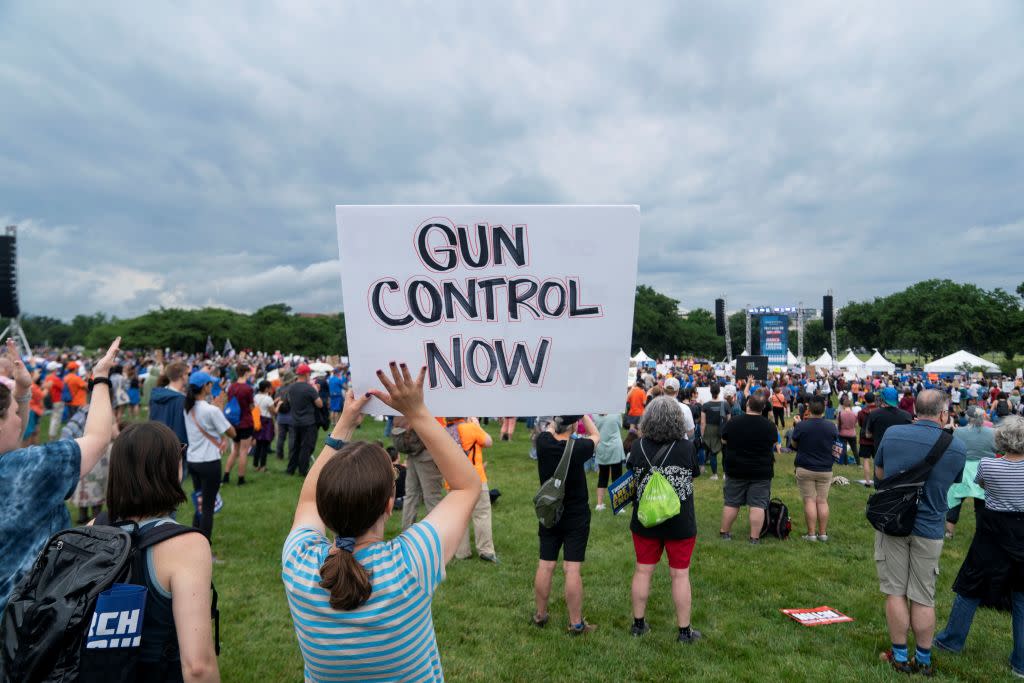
(316, 441), (394, 610)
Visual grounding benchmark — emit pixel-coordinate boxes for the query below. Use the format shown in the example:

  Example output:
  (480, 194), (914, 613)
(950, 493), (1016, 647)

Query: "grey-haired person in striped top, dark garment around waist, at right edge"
(935, 416), (1024, 678)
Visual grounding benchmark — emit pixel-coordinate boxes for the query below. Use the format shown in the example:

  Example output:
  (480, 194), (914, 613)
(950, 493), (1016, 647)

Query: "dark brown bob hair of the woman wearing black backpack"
(106, 422), (185, 521)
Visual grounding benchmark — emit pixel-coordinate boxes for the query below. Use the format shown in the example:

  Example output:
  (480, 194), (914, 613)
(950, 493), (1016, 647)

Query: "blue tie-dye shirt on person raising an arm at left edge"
(0, 440), (82, 612)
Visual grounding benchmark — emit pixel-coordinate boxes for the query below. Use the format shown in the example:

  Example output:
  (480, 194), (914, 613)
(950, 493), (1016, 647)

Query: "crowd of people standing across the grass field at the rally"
(0, 340), (1024, 681)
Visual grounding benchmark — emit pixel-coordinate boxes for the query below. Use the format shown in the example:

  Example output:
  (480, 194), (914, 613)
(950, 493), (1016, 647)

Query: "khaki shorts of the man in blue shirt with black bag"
(874, 531), (942, 607)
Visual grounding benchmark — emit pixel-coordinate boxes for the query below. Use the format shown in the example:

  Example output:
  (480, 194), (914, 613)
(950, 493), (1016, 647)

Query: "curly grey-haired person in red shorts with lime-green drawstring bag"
(626, 396), (700, 643)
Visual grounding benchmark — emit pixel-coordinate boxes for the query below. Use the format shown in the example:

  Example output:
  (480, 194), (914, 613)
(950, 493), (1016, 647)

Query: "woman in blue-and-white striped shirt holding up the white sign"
(282, 362), (480, 681)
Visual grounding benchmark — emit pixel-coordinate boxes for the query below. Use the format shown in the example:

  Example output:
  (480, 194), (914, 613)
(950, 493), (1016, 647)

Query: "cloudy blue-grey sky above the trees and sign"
(0, 0), (1024, 317)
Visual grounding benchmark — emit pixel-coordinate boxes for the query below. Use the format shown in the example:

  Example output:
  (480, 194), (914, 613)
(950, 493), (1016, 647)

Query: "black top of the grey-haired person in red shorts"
(626, 438), (700, 541)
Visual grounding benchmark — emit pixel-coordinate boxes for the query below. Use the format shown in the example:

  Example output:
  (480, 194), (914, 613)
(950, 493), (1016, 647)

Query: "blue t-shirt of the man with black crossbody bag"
(874, 420), (967, 539)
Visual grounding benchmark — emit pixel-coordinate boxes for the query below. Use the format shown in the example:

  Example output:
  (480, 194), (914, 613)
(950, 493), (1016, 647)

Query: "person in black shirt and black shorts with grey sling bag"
(534, 415), (601, 635)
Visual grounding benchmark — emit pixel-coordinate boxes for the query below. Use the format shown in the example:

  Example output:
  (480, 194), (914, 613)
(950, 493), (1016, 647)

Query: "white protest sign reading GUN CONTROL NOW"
(337, 206), (640, 417)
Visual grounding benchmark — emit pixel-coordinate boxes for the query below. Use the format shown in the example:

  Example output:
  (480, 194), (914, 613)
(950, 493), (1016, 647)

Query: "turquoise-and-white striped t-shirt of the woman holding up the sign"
(281, 521), (444, 681)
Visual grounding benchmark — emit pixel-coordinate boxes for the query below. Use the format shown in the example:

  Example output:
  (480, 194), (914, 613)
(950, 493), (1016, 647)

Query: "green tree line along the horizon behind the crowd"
(22, 280), (1024, 366)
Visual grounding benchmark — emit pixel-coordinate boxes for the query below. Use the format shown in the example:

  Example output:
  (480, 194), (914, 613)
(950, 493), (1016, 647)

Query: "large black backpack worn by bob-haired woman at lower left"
(0, 524), (220, 683)
